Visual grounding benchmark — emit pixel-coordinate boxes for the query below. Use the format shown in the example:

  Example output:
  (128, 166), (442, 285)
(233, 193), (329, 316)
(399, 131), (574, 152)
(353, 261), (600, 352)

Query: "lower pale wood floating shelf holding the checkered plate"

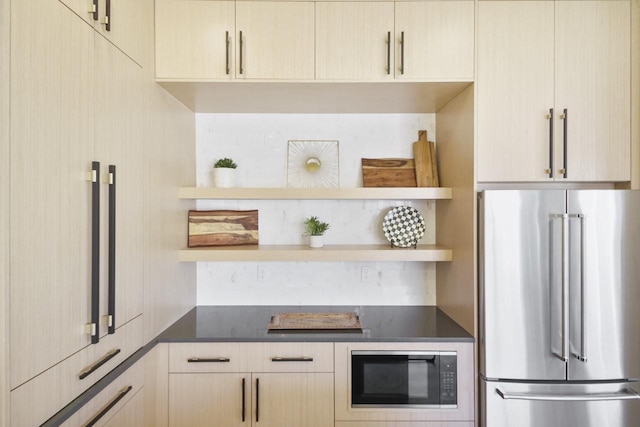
(179, 244), (453, 262)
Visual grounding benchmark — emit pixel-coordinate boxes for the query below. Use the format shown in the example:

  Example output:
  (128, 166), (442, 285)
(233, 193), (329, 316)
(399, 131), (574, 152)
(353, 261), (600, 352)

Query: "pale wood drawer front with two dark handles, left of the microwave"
(169, 342), (333, 373)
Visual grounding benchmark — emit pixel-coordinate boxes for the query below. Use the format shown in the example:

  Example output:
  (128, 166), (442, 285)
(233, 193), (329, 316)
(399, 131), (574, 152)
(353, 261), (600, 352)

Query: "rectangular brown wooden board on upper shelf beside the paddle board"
(362, 159), (417, 187)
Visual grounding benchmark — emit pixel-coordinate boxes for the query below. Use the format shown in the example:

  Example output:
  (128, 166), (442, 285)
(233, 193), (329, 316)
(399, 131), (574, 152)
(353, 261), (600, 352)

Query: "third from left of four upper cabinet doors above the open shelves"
(316, 2), (395, 80)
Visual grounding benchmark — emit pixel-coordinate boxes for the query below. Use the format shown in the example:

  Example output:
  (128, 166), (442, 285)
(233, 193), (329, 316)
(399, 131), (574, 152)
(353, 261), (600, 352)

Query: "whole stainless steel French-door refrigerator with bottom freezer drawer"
(478, 190), (640, 427)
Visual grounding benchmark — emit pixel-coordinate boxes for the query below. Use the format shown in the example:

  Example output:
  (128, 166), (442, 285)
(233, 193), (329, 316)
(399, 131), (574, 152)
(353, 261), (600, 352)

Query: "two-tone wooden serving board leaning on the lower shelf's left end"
(188, 210), (258, 248)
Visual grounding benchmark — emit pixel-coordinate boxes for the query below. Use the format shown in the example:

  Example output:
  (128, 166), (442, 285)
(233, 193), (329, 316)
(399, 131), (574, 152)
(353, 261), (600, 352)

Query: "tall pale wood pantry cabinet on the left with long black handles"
(0, 0), (195, 426)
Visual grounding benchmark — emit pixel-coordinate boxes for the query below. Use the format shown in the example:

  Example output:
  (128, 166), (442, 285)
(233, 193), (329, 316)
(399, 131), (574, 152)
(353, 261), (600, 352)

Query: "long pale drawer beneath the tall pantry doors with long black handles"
(10, 316), (143, 426)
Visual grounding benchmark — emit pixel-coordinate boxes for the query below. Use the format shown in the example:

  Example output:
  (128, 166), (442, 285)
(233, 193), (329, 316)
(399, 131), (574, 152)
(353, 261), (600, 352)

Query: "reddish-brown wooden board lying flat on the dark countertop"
(269, 312), (362, 332)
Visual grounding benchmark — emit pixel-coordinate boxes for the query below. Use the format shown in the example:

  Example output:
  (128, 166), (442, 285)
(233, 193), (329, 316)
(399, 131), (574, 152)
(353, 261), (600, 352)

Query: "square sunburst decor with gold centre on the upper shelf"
(287, 141), (340, 188)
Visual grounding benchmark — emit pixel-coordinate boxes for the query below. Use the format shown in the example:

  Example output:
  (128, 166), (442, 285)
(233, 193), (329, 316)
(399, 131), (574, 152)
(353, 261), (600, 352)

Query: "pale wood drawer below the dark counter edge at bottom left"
(62, 360), (144, 427)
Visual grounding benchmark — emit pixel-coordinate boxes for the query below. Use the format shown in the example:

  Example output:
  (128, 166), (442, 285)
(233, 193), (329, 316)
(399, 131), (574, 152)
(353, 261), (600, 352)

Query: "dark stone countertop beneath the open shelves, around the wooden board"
(158, 306), (474, 342)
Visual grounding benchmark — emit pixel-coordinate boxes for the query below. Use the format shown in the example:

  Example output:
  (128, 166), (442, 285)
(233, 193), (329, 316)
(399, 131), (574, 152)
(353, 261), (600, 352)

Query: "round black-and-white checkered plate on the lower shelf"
(382, 206), (426, 248)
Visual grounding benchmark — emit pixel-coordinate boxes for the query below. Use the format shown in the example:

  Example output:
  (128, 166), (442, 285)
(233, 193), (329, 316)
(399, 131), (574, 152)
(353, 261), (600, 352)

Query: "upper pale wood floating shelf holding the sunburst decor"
(178, 187), (452, 200)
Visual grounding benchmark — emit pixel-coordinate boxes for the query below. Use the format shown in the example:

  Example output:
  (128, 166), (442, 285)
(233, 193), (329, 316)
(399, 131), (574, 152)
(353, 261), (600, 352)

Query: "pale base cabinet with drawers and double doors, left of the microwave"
(169, 343), (334, 427)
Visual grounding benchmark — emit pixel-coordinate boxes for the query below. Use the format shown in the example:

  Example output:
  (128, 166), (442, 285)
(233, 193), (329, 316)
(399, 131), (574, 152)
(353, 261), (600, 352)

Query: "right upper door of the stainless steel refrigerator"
(568, 190), (640, 381)
